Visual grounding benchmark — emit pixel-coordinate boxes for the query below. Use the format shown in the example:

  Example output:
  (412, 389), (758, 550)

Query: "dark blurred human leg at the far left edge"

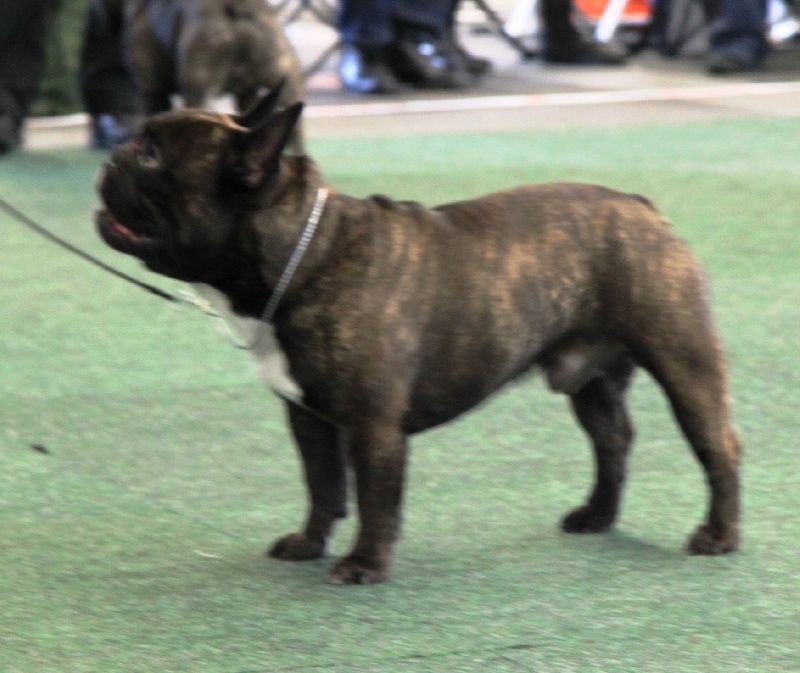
(0, 0), (53, 154)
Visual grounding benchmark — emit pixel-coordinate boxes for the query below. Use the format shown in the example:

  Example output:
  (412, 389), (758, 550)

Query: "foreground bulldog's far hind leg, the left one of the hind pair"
(561, 355), (634, 533)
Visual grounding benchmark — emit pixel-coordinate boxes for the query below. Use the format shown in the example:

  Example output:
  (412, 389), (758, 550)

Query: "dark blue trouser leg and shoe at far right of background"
(707, 0), (769, 75)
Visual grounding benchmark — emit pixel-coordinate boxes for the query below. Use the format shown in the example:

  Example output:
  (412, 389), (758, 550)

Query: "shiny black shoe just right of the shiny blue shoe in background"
(389, 29), (472, 89)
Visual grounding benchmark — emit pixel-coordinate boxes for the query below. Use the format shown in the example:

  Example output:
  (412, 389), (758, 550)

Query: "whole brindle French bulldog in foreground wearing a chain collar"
(96, 85), (740, 584)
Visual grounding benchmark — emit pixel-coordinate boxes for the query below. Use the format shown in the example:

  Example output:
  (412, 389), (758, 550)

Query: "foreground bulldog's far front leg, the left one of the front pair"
(268, 402), (347, 561)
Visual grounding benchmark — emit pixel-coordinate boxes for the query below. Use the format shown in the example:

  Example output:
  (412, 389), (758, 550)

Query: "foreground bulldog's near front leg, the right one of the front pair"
(330, 419), (407, 584)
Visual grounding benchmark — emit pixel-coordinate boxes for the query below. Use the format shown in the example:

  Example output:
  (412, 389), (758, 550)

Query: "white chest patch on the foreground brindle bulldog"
(192, 283), (303, 404)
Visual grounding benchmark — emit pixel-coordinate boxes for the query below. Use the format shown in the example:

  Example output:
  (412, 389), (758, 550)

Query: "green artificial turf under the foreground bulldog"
(0, 119), (800, 673)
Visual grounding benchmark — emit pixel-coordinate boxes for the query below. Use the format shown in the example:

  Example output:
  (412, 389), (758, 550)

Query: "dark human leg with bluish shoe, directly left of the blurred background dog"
(78, 0), (142, 150)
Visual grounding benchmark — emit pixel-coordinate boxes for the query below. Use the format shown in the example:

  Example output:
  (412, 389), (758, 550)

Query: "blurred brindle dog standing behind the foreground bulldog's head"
(106, 0), (305, 154)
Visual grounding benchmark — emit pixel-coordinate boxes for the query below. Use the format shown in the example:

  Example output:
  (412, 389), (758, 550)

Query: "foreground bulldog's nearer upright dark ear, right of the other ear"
(234, 103), (303, 189)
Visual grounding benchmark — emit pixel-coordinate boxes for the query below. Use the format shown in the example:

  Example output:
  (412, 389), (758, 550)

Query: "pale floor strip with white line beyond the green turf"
(26, 6), (800, 148)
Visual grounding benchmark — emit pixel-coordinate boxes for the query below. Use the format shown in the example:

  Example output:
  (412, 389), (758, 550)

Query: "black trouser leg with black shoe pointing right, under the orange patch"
(540, 0), (628, 65)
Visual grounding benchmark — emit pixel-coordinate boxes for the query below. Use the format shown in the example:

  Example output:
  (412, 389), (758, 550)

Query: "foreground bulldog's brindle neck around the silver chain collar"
(210, 156), (336, 317)
